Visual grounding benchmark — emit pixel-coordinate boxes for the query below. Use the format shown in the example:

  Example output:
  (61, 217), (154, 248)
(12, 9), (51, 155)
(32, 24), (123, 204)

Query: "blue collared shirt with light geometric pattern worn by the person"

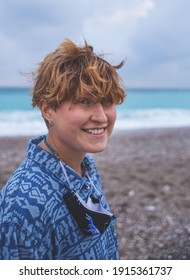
(0, 137), (118, 260)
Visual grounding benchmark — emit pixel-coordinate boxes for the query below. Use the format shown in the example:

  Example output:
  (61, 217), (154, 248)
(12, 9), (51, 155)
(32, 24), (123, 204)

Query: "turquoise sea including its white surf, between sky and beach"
(0, 88), (190, 136)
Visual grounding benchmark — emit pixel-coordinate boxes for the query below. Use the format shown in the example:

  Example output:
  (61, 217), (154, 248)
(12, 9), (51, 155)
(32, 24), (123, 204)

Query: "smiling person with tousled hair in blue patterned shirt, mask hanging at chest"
(0, 40), (125, 260)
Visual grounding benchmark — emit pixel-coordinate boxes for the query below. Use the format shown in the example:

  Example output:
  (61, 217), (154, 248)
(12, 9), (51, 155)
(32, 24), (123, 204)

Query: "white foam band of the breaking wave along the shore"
(0, 109), (190, 136)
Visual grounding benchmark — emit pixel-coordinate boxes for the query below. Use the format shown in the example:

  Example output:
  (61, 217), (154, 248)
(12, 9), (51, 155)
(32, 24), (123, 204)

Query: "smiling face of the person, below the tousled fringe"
(49, 98), (116, 156)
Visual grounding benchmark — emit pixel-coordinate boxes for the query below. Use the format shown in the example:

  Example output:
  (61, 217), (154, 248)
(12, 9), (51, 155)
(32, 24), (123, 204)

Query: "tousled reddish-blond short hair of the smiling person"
(32, 39), (126, 110)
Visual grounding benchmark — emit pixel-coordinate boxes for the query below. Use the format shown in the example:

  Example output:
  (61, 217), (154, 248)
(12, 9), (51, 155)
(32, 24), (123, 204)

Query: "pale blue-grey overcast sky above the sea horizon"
(0, 0), (190, 87)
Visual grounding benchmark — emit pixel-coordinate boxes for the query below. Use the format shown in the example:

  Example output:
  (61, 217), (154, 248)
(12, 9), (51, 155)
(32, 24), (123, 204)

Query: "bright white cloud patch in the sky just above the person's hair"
(83, 0), (154, 52)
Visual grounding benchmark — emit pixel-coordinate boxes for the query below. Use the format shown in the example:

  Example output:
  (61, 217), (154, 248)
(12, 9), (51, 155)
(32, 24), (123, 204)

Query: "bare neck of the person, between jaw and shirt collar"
(41, 135), (85, 176)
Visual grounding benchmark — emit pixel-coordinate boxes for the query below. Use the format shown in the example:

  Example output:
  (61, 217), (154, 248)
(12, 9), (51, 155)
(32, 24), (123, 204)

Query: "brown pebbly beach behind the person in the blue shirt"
(0, 128), (190, 260)
